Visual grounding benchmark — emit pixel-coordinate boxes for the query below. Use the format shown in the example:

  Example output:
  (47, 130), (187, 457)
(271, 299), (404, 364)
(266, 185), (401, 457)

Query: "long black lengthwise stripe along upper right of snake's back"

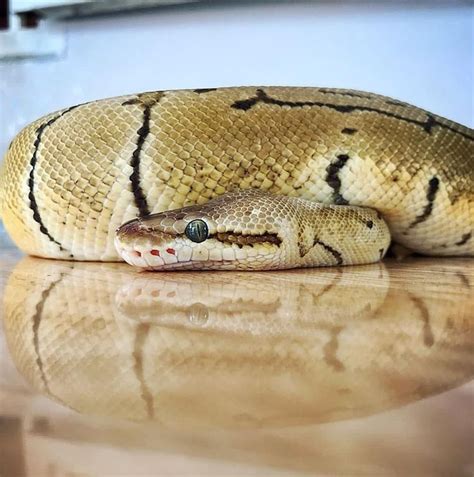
(231, 89), (474, 141)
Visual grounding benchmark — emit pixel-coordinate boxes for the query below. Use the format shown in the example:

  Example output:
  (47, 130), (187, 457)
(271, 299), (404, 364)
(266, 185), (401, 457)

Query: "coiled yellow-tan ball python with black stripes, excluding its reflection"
(0, 87), (474, 269)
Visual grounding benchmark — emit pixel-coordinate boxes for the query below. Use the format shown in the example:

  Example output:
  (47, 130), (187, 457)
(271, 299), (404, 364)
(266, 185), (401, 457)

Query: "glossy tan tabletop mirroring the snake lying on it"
(0, 249), (474, 477)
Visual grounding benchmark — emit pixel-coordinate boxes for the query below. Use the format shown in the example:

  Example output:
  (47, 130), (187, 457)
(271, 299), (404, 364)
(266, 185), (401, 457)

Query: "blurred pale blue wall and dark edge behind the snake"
(0, 0), (474, 245)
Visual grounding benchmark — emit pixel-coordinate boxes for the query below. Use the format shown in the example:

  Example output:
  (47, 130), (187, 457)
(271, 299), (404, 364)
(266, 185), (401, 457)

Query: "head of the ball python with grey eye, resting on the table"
(115, 189), (282, 270)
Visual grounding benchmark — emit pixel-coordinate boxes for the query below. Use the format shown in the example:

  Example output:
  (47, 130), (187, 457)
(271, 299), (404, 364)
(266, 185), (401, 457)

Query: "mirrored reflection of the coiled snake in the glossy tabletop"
(4, 258), (474, 428)
